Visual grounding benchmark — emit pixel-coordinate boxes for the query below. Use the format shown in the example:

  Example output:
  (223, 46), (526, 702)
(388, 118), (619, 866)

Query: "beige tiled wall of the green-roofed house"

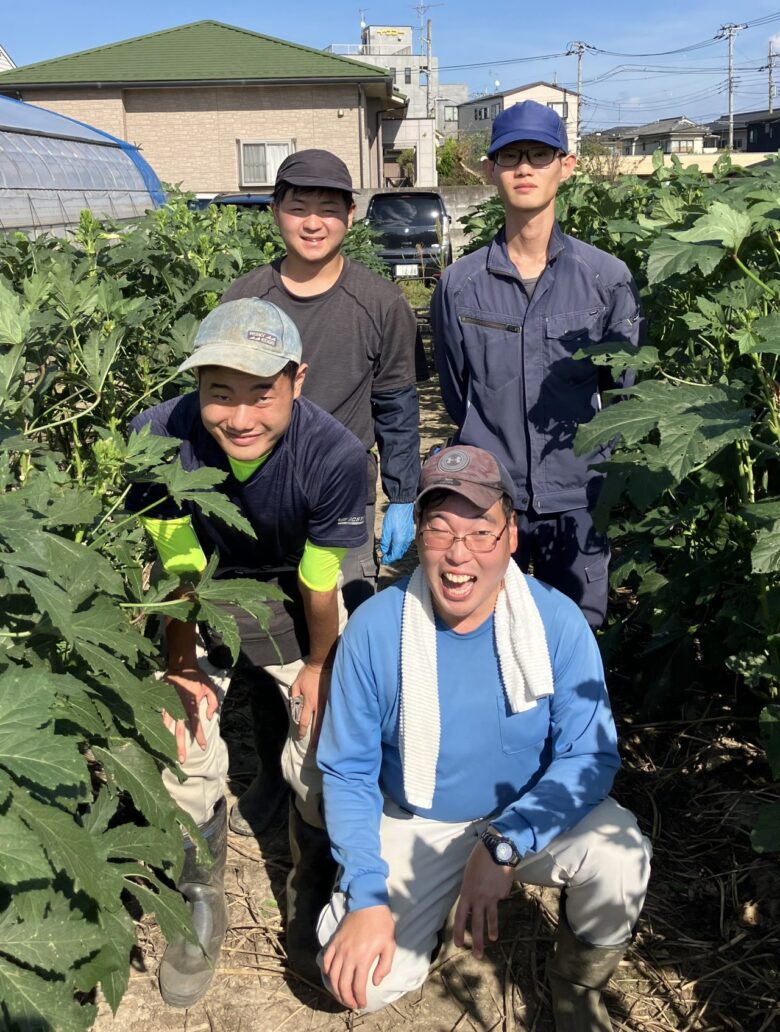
(17, 84), (376, 193)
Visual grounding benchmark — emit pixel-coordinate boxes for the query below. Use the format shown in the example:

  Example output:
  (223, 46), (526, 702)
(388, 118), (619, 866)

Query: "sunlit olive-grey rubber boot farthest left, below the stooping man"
(158, 799), (228, 1007)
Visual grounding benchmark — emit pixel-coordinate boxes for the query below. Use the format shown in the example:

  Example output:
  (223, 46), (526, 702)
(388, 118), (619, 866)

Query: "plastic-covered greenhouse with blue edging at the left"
(0, 97), (165, 236)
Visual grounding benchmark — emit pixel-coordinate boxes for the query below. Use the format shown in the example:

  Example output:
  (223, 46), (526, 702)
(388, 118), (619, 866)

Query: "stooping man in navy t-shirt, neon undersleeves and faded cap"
(129, 298), (367, 1007)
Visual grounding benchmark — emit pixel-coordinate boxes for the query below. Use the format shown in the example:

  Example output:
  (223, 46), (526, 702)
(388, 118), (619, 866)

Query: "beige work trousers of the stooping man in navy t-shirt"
(163, 591), (347, 828)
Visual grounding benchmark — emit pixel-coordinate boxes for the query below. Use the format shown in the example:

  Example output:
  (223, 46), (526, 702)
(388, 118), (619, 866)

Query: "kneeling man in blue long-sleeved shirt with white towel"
(318, 446), (651, 1032)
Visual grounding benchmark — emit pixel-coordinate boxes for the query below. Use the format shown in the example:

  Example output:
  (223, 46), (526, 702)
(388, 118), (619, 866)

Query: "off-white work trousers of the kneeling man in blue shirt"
(317, 799), (652, 1011)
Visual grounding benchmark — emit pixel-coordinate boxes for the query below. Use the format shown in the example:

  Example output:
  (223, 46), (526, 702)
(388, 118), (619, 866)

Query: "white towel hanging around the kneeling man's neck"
(400, 560), (554, 809)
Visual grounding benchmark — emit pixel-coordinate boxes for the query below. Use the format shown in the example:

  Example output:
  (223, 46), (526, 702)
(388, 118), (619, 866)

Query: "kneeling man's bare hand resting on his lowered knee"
(322, 906), (395, 1010)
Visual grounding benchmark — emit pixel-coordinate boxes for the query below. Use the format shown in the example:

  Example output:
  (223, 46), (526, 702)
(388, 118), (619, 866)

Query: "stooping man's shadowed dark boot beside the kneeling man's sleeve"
(287, 800), (337, 986)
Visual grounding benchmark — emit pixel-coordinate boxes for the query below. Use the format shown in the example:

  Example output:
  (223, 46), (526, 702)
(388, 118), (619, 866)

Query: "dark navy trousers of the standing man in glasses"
(515, 509), (610, 631)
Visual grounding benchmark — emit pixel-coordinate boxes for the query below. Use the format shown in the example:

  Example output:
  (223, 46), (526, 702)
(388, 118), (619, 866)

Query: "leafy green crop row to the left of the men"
(0, 191), (344, 1032)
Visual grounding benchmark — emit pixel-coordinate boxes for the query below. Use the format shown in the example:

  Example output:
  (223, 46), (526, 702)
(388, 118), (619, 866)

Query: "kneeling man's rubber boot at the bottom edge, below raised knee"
(547, 906), (630, 1032)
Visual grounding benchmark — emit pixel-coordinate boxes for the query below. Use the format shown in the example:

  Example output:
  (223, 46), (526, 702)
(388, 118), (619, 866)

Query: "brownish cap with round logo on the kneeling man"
(415, 445), (515, 516)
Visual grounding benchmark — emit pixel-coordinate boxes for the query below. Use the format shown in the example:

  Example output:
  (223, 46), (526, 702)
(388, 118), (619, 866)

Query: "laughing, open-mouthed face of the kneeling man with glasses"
(417, 493), (517, 634)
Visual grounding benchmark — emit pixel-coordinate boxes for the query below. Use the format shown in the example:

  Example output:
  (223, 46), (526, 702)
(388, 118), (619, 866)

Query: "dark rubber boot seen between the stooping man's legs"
(230, 678), (289, 836)
